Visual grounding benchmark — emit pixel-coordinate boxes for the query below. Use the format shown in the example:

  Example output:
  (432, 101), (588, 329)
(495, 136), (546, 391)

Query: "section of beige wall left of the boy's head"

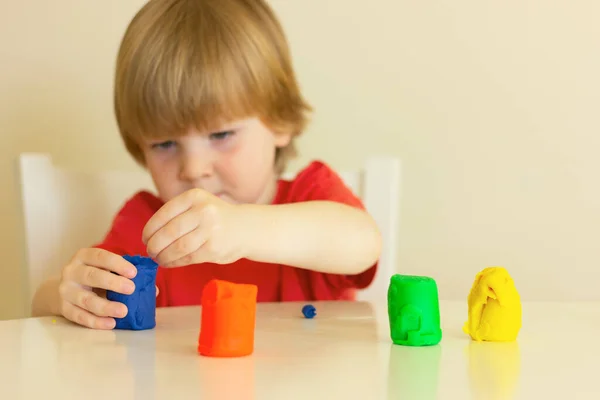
(0, 0), (144, 318)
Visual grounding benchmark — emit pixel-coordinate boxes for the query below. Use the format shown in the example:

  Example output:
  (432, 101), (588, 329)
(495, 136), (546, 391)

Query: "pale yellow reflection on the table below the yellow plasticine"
(465, 341), (521, 400)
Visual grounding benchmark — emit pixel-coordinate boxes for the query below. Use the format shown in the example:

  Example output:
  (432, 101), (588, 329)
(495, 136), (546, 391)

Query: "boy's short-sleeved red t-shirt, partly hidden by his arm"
(95, 161), (377, 307)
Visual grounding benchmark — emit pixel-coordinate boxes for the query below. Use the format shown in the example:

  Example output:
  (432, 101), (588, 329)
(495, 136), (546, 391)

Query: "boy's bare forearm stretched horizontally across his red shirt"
(245, 201), (381, 275)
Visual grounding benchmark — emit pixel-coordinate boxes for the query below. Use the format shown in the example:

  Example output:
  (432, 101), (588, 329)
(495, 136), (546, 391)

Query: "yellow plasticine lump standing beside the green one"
(463, 267), (522, 342)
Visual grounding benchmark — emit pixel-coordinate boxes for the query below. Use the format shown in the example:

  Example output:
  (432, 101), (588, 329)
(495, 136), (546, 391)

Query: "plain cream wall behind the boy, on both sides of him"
(0, 0), (600, 318)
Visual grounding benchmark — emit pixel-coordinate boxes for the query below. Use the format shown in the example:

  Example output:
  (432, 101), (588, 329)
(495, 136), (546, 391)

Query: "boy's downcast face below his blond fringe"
(142, 118), (291, 204)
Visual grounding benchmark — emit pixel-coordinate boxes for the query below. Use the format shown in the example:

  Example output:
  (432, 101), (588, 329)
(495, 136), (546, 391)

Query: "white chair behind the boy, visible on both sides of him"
(19, 153), (400, 310)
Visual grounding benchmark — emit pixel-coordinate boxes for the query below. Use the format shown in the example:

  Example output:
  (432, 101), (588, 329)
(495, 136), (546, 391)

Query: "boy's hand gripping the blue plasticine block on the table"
(58, 249), (137, 329)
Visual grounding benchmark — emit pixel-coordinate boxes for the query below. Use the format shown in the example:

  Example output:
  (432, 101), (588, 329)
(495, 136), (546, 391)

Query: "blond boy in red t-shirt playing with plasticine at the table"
(33, 0), (381, 329)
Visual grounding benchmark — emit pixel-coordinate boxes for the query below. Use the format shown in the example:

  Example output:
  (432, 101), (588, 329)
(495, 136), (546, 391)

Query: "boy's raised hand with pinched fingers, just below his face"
(142, 189), (245, 267)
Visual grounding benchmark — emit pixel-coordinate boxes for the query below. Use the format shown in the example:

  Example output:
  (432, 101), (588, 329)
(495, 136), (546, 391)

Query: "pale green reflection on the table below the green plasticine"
(387, 344), (442, 400)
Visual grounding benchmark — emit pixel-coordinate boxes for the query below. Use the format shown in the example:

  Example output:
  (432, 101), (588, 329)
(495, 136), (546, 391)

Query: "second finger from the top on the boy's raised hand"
(146, 206), (202, 264)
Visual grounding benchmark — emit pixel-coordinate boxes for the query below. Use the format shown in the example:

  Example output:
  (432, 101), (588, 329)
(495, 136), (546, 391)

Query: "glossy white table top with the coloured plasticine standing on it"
(0, 302), (600, 400)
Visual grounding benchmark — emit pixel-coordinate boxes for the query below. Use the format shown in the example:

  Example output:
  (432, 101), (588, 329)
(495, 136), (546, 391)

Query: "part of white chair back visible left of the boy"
(19, 153), (154, 311)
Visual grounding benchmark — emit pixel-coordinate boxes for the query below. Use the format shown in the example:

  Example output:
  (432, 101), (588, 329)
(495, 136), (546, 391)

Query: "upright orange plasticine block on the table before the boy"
(198, 279), (258, 357)
